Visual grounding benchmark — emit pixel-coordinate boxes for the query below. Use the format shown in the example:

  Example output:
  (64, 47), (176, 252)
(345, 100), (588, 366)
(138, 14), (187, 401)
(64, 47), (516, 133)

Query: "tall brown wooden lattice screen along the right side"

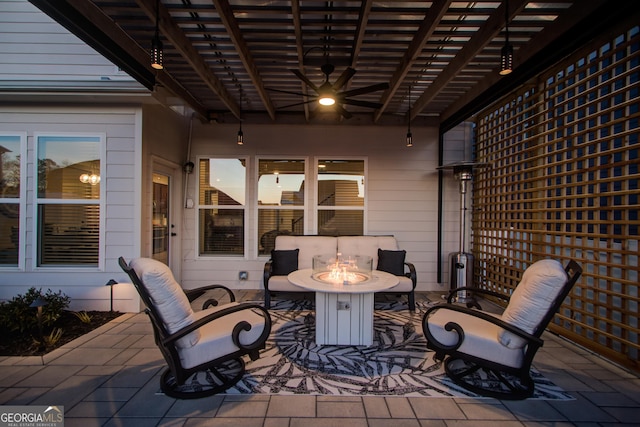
(472, 26), (640, 370)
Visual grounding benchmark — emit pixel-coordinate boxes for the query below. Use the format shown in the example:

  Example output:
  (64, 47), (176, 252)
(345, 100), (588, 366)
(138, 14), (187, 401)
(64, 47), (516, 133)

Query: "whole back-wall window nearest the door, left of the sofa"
(198, 159), (247, 256)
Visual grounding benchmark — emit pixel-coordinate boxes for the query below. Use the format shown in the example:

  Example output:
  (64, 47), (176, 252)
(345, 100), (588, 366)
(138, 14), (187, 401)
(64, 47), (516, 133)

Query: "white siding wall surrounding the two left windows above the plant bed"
(0, 107), (142, 311)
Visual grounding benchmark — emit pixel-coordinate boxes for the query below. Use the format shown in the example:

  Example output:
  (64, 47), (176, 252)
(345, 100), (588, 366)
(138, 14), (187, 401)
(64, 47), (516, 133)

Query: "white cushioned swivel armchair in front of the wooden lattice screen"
(422, 259), (582, 400)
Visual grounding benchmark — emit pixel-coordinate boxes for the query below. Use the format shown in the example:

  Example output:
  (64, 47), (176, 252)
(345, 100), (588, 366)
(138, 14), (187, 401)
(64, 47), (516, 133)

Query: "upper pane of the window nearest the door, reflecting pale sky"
(198, 159), (247, 206)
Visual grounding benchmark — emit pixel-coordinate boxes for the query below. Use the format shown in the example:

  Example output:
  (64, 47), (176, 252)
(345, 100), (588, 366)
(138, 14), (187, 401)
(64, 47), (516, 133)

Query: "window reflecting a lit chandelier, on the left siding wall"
(36, 136), (103, 267)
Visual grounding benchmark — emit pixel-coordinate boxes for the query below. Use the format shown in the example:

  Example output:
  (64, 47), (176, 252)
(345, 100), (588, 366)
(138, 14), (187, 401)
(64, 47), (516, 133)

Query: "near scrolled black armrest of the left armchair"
(162, 303), (271, 350)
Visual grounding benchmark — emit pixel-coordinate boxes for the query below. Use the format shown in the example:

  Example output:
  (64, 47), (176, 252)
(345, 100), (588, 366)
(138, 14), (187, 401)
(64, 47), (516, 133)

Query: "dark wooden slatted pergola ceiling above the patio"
(31, 0), (633, 129)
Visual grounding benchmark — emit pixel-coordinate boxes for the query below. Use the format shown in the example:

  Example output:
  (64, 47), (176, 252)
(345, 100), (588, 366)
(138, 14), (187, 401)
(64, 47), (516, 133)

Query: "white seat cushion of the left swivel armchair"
(178, 302), (265, 369)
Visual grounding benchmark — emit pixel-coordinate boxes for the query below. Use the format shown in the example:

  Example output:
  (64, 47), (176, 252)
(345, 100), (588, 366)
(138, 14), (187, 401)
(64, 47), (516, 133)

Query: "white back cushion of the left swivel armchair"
(129, 258), (200, 348)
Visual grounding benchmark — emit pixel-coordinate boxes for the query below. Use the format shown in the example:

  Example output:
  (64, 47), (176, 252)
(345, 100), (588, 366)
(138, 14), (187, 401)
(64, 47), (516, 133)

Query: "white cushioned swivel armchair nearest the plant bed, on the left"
(118, 257), (271, 399)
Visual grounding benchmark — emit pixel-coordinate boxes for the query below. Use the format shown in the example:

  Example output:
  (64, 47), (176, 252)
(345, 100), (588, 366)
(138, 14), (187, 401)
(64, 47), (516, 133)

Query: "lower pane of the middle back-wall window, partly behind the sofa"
(258, 209), (304, 255)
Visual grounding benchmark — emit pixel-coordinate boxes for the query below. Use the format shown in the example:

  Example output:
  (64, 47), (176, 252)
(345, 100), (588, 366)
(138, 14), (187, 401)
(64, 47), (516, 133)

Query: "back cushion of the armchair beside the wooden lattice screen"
(498, 259), (567, 348)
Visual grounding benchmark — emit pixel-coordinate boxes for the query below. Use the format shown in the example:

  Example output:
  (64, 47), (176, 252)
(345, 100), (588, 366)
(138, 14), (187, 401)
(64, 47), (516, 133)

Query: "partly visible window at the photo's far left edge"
(0, 135), (22, 267)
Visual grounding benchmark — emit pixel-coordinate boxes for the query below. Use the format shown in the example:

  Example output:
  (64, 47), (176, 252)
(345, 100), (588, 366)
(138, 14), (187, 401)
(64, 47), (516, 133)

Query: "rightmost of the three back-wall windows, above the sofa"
(317, 159), (365, 236)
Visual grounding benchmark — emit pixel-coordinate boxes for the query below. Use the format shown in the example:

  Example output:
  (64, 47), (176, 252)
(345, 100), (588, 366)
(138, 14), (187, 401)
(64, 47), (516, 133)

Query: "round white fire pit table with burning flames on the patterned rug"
(288, 257), (398, 346)
